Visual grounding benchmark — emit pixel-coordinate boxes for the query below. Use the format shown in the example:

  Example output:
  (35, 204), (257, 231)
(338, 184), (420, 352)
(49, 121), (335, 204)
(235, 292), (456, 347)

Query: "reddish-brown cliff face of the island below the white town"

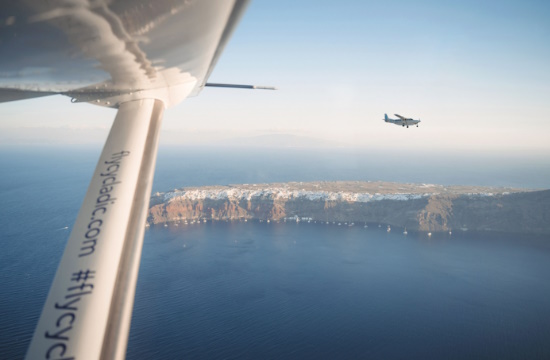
(148, 183), (550, 234)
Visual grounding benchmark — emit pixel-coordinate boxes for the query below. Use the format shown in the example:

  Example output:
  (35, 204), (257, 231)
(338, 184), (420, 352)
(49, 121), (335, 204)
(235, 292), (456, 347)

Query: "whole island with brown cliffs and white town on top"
(147, 181), (550, 234)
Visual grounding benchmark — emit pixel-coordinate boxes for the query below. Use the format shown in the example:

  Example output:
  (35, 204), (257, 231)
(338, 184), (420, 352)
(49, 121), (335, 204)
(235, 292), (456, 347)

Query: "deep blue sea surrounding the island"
(0, 147), (550, 359)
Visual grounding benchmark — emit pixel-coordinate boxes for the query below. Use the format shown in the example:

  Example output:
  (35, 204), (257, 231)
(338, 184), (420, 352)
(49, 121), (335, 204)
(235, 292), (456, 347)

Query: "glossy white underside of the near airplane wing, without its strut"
(0, 0), (248, 107)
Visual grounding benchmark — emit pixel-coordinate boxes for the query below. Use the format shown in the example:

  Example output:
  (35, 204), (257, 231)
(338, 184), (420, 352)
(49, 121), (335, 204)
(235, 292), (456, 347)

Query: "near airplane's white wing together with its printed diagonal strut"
(0, 0), (272, 359)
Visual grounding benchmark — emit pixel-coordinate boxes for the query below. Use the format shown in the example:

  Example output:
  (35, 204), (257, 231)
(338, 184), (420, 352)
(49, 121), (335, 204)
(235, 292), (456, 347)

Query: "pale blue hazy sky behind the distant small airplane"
(0, 0), (550, 153)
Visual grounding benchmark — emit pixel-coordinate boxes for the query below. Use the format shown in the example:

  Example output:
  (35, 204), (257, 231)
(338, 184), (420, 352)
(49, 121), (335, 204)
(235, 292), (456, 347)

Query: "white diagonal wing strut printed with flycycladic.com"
(26, 99), (164, 360)
